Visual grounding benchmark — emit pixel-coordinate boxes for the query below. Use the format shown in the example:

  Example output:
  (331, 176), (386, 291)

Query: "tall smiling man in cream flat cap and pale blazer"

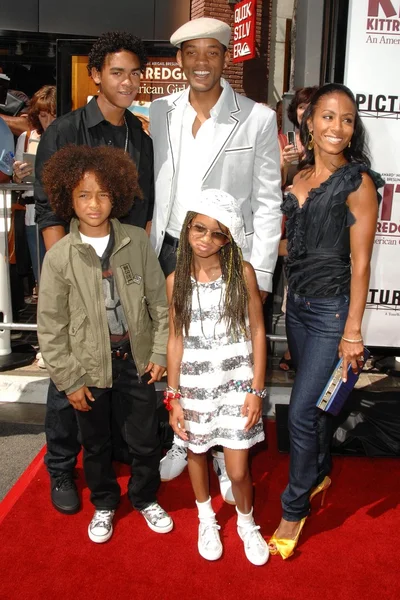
(150, 17), (282, 502)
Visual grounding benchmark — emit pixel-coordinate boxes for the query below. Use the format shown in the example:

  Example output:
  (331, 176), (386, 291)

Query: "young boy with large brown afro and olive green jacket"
(38, 146), (173, 543)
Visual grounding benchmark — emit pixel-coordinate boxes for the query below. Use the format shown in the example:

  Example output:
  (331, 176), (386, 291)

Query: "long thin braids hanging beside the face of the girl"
(172, 212), (249, 339)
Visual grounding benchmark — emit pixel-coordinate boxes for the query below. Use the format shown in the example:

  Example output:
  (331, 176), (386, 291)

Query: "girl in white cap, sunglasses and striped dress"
(164, 190), (269, 565)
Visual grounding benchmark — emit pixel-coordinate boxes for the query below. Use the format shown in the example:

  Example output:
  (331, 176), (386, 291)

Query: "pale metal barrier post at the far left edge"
(0, 183), (35, 371)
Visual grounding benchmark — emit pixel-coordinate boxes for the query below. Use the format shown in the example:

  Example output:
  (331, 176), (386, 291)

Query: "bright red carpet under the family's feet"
(0, 424), (400, 600)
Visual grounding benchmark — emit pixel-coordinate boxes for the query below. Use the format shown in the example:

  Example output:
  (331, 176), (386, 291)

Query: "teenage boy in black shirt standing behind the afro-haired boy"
(34, 32), (154, 514)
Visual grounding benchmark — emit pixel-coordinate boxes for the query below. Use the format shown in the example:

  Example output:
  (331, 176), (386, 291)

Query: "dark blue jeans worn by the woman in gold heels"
(281, 291), (349, 521)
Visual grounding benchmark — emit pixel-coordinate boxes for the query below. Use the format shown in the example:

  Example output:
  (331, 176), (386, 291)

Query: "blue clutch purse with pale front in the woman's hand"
(316, 348), (370, 416)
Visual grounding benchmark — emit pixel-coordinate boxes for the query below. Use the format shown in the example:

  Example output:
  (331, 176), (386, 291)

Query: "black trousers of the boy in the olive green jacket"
(76, 358), (161, 510)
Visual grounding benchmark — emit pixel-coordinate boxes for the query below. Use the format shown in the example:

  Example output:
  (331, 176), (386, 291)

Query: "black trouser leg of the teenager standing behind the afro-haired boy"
(44, 380), (81, 477)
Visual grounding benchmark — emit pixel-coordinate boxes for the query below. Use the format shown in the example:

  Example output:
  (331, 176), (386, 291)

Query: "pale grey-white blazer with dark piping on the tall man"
(150, 79), (282, 291)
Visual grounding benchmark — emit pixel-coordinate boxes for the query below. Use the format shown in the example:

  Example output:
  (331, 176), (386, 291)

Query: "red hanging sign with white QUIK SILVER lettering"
(233, 0), (256, 63)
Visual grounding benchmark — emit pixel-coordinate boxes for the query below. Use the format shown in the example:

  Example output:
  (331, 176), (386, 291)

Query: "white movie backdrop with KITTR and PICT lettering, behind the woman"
(345, 0), (400, 348)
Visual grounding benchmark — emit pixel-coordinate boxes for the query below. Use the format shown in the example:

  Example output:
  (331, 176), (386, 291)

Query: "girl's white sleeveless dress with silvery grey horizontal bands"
(174, 277), (264, 453)
